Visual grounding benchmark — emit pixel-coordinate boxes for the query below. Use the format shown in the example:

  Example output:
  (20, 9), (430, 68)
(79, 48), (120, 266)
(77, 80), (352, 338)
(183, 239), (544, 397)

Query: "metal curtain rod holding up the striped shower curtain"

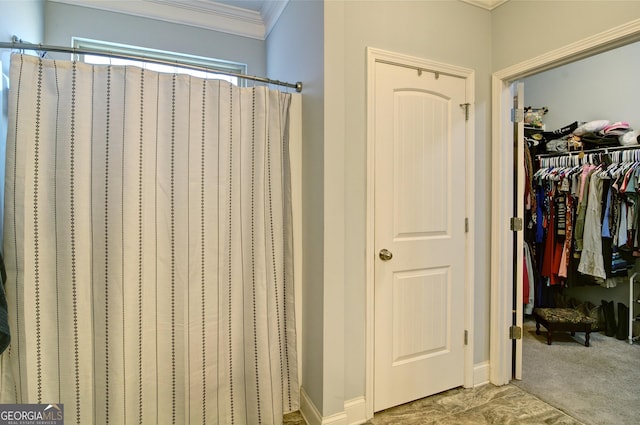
(0, 42), (302, 93)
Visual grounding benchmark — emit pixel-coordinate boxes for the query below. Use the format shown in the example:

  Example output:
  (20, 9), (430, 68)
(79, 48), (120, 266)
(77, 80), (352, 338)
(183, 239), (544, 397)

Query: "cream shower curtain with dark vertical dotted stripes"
(0, 54), (299, 425)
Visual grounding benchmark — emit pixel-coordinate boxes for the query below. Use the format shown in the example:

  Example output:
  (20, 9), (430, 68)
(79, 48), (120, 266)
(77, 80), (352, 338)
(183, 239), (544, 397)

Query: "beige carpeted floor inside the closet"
(513, 320), (640, 425)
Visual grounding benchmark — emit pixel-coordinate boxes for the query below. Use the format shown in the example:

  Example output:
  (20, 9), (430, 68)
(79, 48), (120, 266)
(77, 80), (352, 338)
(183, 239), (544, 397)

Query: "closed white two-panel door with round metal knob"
(373, 62), (466, 411)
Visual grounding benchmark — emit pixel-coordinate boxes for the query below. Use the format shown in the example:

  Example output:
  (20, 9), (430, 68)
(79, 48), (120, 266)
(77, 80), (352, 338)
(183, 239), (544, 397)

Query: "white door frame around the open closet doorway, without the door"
(489, 19), (640, 385)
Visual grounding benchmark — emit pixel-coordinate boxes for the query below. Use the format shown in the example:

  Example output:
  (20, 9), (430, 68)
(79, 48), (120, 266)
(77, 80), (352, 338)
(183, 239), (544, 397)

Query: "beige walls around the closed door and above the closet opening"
(303, 0), (640, 416)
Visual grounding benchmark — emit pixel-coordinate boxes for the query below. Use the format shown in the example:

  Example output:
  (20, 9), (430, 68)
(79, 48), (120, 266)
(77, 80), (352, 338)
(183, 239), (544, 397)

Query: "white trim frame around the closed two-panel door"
(365, 47), (475, 418)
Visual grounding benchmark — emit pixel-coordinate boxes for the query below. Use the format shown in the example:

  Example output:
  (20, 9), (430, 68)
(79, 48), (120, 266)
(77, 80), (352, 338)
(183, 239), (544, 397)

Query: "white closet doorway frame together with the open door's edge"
(490, 22), (640, 385)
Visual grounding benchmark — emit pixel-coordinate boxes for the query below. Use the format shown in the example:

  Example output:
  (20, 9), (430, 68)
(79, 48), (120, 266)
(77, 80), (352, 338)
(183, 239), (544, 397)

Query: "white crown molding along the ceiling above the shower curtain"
(48, 0), (289, 40)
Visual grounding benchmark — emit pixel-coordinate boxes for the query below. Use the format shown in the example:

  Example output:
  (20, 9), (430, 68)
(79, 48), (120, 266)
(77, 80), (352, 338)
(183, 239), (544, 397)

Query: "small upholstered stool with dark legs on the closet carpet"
(533, 308), (597, 347)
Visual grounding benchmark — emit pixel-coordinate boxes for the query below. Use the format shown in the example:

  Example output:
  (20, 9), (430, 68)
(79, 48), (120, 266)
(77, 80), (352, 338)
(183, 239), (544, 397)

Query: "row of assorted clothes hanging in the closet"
(523, 153), (640, 292)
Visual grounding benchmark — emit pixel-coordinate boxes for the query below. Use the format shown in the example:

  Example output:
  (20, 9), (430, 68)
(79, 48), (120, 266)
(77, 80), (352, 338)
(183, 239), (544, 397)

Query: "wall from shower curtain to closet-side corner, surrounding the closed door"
(267, 0), (491, 417)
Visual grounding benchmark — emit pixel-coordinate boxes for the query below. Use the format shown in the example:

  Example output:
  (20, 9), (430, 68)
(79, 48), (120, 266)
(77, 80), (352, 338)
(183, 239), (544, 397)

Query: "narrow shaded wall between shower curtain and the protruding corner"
(266, 1), (328, 408)
